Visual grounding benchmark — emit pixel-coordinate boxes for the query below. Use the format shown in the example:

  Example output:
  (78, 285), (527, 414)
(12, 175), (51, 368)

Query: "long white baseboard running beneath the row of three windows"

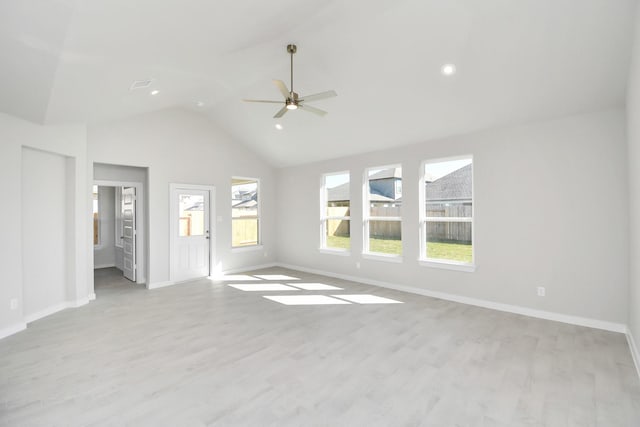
(278, 263), (627, 334)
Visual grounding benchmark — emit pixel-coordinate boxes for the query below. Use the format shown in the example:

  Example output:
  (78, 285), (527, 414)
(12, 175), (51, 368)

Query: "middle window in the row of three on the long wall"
(363, 165), (402, 257)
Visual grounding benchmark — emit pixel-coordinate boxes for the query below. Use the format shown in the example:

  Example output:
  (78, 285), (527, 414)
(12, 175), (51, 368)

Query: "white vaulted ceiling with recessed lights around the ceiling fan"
(0, 0), (636, 166)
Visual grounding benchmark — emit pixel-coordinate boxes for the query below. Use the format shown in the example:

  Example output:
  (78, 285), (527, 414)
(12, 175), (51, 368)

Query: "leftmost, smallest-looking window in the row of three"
(320, 172), (351, 252)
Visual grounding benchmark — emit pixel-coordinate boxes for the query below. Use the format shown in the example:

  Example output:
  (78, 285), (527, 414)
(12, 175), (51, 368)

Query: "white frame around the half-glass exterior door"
(169, 182), (217, 283)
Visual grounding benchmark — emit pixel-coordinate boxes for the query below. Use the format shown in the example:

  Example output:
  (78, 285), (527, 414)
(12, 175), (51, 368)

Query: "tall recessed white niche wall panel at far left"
(22, 148), (68, 318)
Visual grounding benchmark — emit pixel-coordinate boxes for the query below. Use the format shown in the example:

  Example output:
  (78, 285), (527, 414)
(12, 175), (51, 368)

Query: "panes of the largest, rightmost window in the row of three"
(420, 156), (473, 265)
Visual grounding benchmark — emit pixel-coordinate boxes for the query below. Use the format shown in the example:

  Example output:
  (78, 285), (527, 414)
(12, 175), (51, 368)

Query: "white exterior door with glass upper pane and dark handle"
(171, 187), (211, 281)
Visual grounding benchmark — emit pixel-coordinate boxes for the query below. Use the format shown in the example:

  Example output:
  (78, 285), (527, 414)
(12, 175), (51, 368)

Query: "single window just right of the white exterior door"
(231, 178), (260, 248)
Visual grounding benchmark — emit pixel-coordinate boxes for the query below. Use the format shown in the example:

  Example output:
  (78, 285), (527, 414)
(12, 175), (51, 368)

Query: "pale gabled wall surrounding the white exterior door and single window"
(88, 109), (276, 286)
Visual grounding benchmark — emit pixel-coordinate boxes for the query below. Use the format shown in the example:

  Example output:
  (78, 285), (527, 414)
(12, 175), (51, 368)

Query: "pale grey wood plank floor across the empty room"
(0, 268), (640, 427)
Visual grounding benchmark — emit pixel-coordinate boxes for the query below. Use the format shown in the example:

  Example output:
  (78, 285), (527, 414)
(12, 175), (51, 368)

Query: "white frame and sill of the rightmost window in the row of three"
(418, 154), (476, 272)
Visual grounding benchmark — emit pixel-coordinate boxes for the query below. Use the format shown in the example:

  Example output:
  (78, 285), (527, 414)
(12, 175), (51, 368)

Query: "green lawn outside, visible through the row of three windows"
(327, 236), (472, 263)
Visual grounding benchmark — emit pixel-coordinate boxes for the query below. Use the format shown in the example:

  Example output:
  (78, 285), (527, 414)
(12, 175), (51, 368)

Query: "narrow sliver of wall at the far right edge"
(627, 7), (640, 352)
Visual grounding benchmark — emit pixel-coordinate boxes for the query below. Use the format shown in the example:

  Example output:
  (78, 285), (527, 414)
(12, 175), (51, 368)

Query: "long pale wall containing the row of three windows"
(277, 111), (628, 324)
